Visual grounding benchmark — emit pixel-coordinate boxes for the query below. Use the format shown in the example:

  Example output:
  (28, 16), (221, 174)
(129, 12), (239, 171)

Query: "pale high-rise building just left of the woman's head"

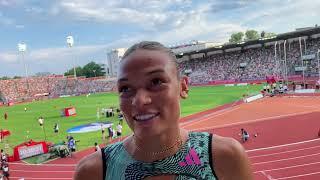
(106, 48), (127, 77)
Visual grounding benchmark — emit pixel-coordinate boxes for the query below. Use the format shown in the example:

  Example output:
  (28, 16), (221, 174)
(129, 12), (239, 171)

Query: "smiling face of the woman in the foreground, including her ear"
(118, 49), (187, 136)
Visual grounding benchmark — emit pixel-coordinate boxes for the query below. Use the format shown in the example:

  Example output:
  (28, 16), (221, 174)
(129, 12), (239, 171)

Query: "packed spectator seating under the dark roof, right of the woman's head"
(178, 38), (320, 84)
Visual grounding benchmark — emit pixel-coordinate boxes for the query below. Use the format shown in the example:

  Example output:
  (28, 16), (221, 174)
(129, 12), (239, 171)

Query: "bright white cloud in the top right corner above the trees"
(242, 0), (320, 33)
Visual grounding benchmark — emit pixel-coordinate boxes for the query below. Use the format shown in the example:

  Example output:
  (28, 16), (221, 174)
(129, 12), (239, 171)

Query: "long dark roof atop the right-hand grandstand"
(177, 26), (320, 57)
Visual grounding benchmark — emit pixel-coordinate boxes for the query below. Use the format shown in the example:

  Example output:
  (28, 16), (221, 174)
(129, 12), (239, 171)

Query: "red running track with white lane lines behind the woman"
(6, 97), (320, 180)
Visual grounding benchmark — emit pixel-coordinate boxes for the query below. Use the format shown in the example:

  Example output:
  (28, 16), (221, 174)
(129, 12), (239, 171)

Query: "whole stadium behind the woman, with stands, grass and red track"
(0, 27), (320, 180)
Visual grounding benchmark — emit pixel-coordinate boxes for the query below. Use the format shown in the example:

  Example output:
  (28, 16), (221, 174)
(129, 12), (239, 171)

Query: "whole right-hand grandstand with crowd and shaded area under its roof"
(178, 28), (320, 84)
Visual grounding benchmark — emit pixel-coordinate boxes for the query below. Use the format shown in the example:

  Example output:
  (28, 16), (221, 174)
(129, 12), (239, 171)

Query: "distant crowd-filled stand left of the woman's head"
(0, 76), (115, 103)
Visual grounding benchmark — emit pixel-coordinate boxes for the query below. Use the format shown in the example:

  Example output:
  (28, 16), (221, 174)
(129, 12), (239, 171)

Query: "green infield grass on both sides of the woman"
(0, 85), (261, 154)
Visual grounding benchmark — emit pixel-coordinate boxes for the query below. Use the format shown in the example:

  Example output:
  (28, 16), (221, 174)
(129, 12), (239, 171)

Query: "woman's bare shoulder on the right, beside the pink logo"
(212, 135), (253, 180)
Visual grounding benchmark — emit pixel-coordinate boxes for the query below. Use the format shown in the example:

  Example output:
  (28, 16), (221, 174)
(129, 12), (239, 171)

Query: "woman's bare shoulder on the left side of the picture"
(74, 151), (103, 180)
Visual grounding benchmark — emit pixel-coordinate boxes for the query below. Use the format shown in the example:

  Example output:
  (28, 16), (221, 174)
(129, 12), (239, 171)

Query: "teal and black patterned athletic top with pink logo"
(102, 132), (218, 180)
